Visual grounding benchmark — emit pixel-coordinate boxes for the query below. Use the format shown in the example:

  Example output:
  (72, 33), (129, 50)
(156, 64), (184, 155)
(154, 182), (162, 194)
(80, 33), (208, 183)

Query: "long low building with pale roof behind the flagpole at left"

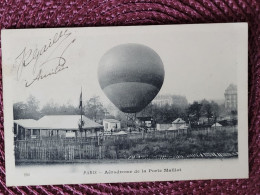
(14, 115), (104, 140)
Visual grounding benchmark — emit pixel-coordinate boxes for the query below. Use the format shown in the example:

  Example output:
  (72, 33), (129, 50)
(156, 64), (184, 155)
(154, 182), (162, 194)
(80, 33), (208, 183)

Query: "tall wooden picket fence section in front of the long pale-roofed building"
(15, 138), (104, 162)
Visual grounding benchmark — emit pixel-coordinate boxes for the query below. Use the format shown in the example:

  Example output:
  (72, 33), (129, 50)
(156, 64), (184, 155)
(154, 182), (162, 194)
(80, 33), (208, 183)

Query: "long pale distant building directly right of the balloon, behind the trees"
(152, 95), (188, 106)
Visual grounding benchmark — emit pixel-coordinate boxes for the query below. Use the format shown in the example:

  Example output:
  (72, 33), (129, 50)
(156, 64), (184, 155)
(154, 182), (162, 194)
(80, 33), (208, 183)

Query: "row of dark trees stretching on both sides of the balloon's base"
(13, 96), (231, 124)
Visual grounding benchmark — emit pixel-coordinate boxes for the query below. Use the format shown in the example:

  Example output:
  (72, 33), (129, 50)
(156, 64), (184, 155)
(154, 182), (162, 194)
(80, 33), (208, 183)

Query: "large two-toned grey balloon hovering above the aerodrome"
(98, 43), (164, 113)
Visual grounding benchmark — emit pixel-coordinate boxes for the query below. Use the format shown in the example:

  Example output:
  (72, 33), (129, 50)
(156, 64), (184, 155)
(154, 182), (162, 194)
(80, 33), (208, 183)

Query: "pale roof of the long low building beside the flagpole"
(15, 115), (103, 130)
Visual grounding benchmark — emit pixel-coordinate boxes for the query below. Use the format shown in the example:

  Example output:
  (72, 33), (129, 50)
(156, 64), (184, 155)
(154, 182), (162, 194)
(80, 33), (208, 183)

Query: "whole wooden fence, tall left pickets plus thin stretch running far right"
(15, 126), (237, 162)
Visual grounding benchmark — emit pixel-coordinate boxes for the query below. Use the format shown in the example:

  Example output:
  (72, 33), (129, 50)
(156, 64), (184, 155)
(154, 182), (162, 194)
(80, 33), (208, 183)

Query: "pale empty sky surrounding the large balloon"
(3, 24), (240, 106)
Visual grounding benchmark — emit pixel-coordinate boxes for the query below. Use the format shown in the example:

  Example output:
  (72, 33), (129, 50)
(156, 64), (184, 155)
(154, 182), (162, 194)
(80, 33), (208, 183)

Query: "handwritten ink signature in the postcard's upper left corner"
(14, 29), (76, 87)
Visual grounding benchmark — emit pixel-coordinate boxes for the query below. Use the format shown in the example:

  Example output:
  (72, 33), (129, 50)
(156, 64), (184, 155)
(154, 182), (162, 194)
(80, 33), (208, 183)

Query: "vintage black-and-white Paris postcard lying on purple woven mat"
(1, 23), (248, 186)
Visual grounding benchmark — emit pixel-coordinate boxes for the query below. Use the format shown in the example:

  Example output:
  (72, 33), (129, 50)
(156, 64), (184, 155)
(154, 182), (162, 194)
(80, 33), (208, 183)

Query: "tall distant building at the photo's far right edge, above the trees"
(224, 84), (237, 111)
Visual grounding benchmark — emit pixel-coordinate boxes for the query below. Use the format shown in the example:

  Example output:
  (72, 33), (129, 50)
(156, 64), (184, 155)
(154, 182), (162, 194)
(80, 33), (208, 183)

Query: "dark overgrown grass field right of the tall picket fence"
(104, 130), (238, 159)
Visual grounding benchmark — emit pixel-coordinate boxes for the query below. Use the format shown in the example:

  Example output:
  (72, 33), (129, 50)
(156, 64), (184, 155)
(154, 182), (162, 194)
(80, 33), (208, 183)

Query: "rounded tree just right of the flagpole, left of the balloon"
(83, 96), (106, 121)
